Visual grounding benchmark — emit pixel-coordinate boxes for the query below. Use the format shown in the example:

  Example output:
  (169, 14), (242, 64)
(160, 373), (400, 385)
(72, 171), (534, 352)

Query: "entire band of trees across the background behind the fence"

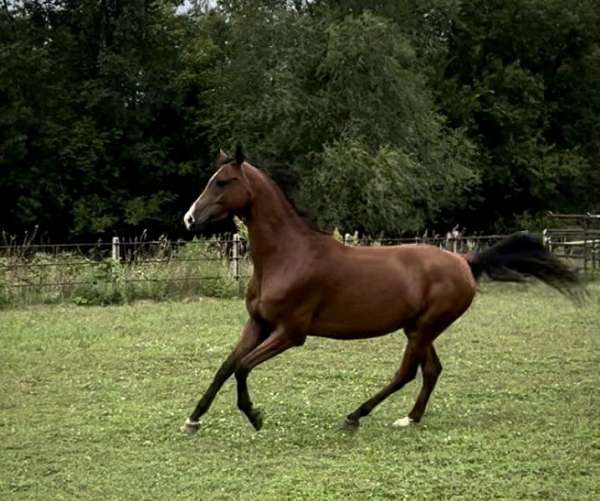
(0, 0), (600, 236)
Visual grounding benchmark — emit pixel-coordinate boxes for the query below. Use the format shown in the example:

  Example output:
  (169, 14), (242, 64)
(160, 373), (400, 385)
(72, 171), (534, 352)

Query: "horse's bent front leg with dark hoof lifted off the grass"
(235, 328), (304, 431)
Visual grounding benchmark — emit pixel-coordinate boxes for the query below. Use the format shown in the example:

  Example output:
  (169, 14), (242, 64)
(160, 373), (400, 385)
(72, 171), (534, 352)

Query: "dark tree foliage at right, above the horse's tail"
(435, 0), (600, 229)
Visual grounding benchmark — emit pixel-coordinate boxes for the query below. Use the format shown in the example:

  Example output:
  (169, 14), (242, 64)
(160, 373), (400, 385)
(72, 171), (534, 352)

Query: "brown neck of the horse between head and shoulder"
(246, 166), (310, 275)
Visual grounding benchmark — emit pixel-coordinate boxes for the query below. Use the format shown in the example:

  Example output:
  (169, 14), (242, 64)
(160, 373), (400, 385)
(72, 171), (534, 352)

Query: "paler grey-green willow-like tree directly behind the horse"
(197, 2), (476, 234)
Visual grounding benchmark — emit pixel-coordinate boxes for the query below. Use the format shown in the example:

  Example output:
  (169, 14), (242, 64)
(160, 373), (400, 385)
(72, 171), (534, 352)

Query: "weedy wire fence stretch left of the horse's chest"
(0, 236), (252, 304)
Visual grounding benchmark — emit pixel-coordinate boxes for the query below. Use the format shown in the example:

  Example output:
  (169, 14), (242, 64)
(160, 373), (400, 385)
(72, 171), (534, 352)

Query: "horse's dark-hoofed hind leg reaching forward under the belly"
(344, 336), (425, 430)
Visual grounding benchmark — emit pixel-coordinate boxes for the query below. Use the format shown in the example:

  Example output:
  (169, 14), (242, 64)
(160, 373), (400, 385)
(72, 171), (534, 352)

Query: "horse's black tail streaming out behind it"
(467, 232), (585, 300)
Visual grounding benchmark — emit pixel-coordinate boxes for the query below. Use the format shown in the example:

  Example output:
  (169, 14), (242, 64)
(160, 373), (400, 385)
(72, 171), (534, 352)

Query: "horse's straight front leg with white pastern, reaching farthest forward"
(181, 319), (265, 434)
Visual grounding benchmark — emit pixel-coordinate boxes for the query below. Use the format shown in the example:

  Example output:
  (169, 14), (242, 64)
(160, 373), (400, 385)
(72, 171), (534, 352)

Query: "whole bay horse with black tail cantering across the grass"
(182, 147), (581, 434)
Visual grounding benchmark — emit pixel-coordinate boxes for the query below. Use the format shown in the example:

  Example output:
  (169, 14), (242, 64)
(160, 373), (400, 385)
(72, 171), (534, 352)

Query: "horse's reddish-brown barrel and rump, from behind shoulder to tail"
(310, 246), (475, 339)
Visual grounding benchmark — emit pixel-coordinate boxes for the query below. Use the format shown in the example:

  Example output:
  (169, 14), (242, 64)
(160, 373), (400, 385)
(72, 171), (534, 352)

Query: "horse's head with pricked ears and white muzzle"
(183, 146), (250, 230)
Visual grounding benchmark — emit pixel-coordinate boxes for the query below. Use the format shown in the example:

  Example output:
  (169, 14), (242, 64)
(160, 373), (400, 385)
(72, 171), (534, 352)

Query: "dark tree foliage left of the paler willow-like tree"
(0, 0), (211, 237)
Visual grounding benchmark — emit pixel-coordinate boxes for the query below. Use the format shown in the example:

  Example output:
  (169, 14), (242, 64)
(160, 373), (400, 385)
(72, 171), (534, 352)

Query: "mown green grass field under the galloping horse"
(0, 285), (600, 501)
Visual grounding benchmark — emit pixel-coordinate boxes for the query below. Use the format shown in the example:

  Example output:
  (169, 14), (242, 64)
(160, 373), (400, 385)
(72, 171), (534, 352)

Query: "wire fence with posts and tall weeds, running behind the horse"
(0, 228), (600, 304)
